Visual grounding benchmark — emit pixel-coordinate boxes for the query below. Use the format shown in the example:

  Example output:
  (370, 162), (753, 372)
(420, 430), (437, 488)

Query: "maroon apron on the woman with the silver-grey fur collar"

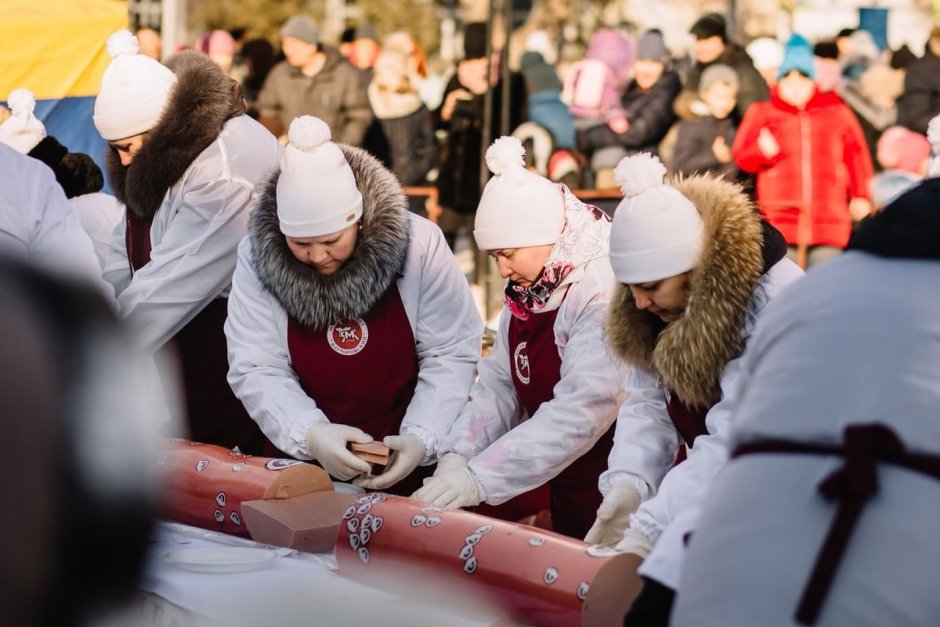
(280, 283), (430, 496)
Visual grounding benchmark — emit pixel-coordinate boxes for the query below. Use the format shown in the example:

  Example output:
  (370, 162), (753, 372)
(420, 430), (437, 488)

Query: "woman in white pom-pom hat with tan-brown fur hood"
(586, 154), (803, 624)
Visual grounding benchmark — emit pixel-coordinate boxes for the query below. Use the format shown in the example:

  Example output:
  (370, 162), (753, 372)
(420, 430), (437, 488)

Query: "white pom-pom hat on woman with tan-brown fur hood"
(610, 152), (704, 285)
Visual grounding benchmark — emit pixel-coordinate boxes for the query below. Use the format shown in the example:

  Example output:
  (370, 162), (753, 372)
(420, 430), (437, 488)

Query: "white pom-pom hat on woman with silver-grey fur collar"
(277, 115), (362, 237)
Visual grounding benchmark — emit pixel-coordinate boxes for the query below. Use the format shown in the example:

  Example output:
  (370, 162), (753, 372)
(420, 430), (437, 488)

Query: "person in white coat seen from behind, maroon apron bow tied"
(673, 179), (940, 627)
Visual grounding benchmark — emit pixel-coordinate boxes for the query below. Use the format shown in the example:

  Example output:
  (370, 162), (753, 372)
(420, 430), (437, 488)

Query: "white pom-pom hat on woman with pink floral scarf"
(473, 137), (565, 250)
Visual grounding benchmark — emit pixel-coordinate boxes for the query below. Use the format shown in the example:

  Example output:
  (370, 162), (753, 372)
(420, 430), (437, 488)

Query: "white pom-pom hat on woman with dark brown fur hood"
(94, 30), (176, 141)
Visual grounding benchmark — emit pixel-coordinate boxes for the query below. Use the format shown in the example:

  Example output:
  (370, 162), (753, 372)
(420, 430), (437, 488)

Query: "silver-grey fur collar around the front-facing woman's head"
(250, 144), (410, 329)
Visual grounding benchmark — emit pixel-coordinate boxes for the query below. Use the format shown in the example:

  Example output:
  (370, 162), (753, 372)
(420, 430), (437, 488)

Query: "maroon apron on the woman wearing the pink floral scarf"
(488, 300), (614, 539)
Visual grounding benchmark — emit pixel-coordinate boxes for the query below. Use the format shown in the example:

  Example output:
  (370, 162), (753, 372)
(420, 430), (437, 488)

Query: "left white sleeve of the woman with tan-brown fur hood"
(599, 368), (679, 498)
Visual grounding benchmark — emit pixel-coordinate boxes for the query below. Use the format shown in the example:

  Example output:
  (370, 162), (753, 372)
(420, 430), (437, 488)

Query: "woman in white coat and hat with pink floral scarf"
(414, 137), (624, 538)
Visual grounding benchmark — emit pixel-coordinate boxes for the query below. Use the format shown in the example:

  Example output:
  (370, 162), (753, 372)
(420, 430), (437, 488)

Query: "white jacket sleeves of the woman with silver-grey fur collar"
(225, 213), (483, 463)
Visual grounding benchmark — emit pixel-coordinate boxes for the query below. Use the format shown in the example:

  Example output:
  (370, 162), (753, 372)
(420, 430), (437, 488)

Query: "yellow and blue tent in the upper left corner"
(0, 0), (127, 179)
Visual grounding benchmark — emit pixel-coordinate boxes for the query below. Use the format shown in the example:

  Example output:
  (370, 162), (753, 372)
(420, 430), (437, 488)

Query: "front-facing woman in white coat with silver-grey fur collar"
(225, 116), (483, 494)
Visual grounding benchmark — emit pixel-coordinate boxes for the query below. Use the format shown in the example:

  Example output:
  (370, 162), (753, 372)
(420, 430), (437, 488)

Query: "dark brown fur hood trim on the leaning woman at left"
(105, 50), (245, 217)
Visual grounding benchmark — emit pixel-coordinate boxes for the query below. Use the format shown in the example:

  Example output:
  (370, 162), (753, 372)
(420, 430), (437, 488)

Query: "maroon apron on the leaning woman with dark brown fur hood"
(124, 210), (264, 455)
